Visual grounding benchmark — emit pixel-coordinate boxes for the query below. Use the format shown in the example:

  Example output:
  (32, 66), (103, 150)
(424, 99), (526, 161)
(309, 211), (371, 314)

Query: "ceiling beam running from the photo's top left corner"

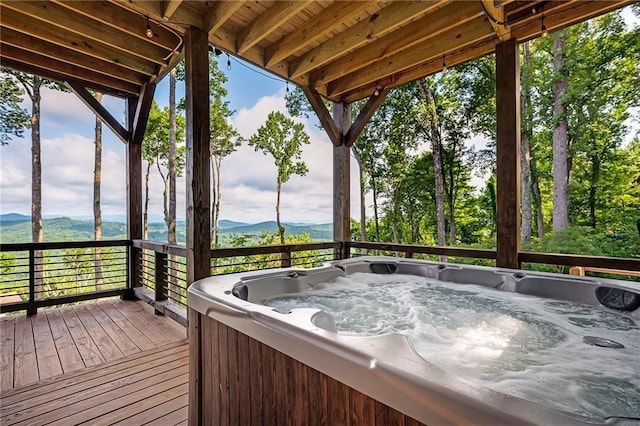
(2, 1), (169, 65)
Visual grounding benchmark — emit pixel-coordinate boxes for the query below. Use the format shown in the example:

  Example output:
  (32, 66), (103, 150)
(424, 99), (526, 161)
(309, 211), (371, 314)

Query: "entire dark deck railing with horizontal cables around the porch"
(0, 240), (640, 318)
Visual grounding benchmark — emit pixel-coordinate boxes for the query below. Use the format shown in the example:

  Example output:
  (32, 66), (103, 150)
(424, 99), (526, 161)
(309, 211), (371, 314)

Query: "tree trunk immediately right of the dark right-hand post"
(520, 41), (533, 244)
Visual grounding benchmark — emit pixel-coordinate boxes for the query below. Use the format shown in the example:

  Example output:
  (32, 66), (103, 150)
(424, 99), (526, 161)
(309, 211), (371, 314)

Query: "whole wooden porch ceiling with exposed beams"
(0, 0), (633, 102)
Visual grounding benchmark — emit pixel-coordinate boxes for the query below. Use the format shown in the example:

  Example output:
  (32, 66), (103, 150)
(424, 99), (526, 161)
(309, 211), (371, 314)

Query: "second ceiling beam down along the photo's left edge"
(2, 28), (148, 85)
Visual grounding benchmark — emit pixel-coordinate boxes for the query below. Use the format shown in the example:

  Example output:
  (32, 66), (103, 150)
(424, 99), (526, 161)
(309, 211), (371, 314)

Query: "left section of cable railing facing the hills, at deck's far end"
(0, 240), (130, 314)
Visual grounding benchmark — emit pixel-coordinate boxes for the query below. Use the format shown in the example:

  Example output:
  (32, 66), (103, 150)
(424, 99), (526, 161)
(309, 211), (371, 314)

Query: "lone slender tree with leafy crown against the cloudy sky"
(249, 112), (310, 244)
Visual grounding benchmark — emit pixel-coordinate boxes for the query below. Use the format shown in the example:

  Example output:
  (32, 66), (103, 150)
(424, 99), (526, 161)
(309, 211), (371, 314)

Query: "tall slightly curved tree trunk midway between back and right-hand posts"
(418, 79), (446, 261)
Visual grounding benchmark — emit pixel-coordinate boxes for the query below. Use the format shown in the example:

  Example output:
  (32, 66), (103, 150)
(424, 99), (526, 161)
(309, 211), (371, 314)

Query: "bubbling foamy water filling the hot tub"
(262, 273), (640, 418)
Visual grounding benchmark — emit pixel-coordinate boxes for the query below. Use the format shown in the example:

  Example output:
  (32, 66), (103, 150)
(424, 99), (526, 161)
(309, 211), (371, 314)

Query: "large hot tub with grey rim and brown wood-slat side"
(188, 257), (640, 425)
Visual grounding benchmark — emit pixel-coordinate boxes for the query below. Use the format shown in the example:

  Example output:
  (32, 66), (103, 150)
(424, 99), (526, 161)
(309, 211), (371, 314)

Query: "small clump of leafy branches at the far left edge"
(0, 73), (29, 146)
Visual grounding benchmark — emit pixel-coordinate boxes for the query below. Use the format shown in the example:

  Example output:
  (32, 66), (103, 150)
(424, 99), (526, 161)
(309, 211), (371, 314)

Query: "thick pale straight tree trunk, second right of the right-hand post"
(553, 31), (569, 231)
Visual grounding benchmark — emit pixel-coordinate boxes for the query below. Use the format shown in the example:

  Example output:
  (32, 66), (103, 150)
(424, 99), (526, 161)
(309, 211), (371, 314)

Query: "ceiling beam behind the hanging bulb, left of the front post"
(56, 0), (182, 51)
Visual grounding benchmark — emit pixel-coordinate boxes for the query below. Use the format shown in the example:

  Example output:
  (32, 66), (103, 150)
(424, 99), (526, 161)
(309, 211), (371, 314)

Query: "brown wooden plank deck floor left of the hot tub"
(0, 300), (188, 425)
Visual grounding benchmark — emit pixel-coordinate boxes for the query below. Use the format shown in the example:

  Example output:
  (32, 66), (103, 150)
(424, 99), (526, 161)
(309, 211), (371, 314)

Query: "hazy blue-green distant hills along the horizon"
(0, 213), (333, 245)
